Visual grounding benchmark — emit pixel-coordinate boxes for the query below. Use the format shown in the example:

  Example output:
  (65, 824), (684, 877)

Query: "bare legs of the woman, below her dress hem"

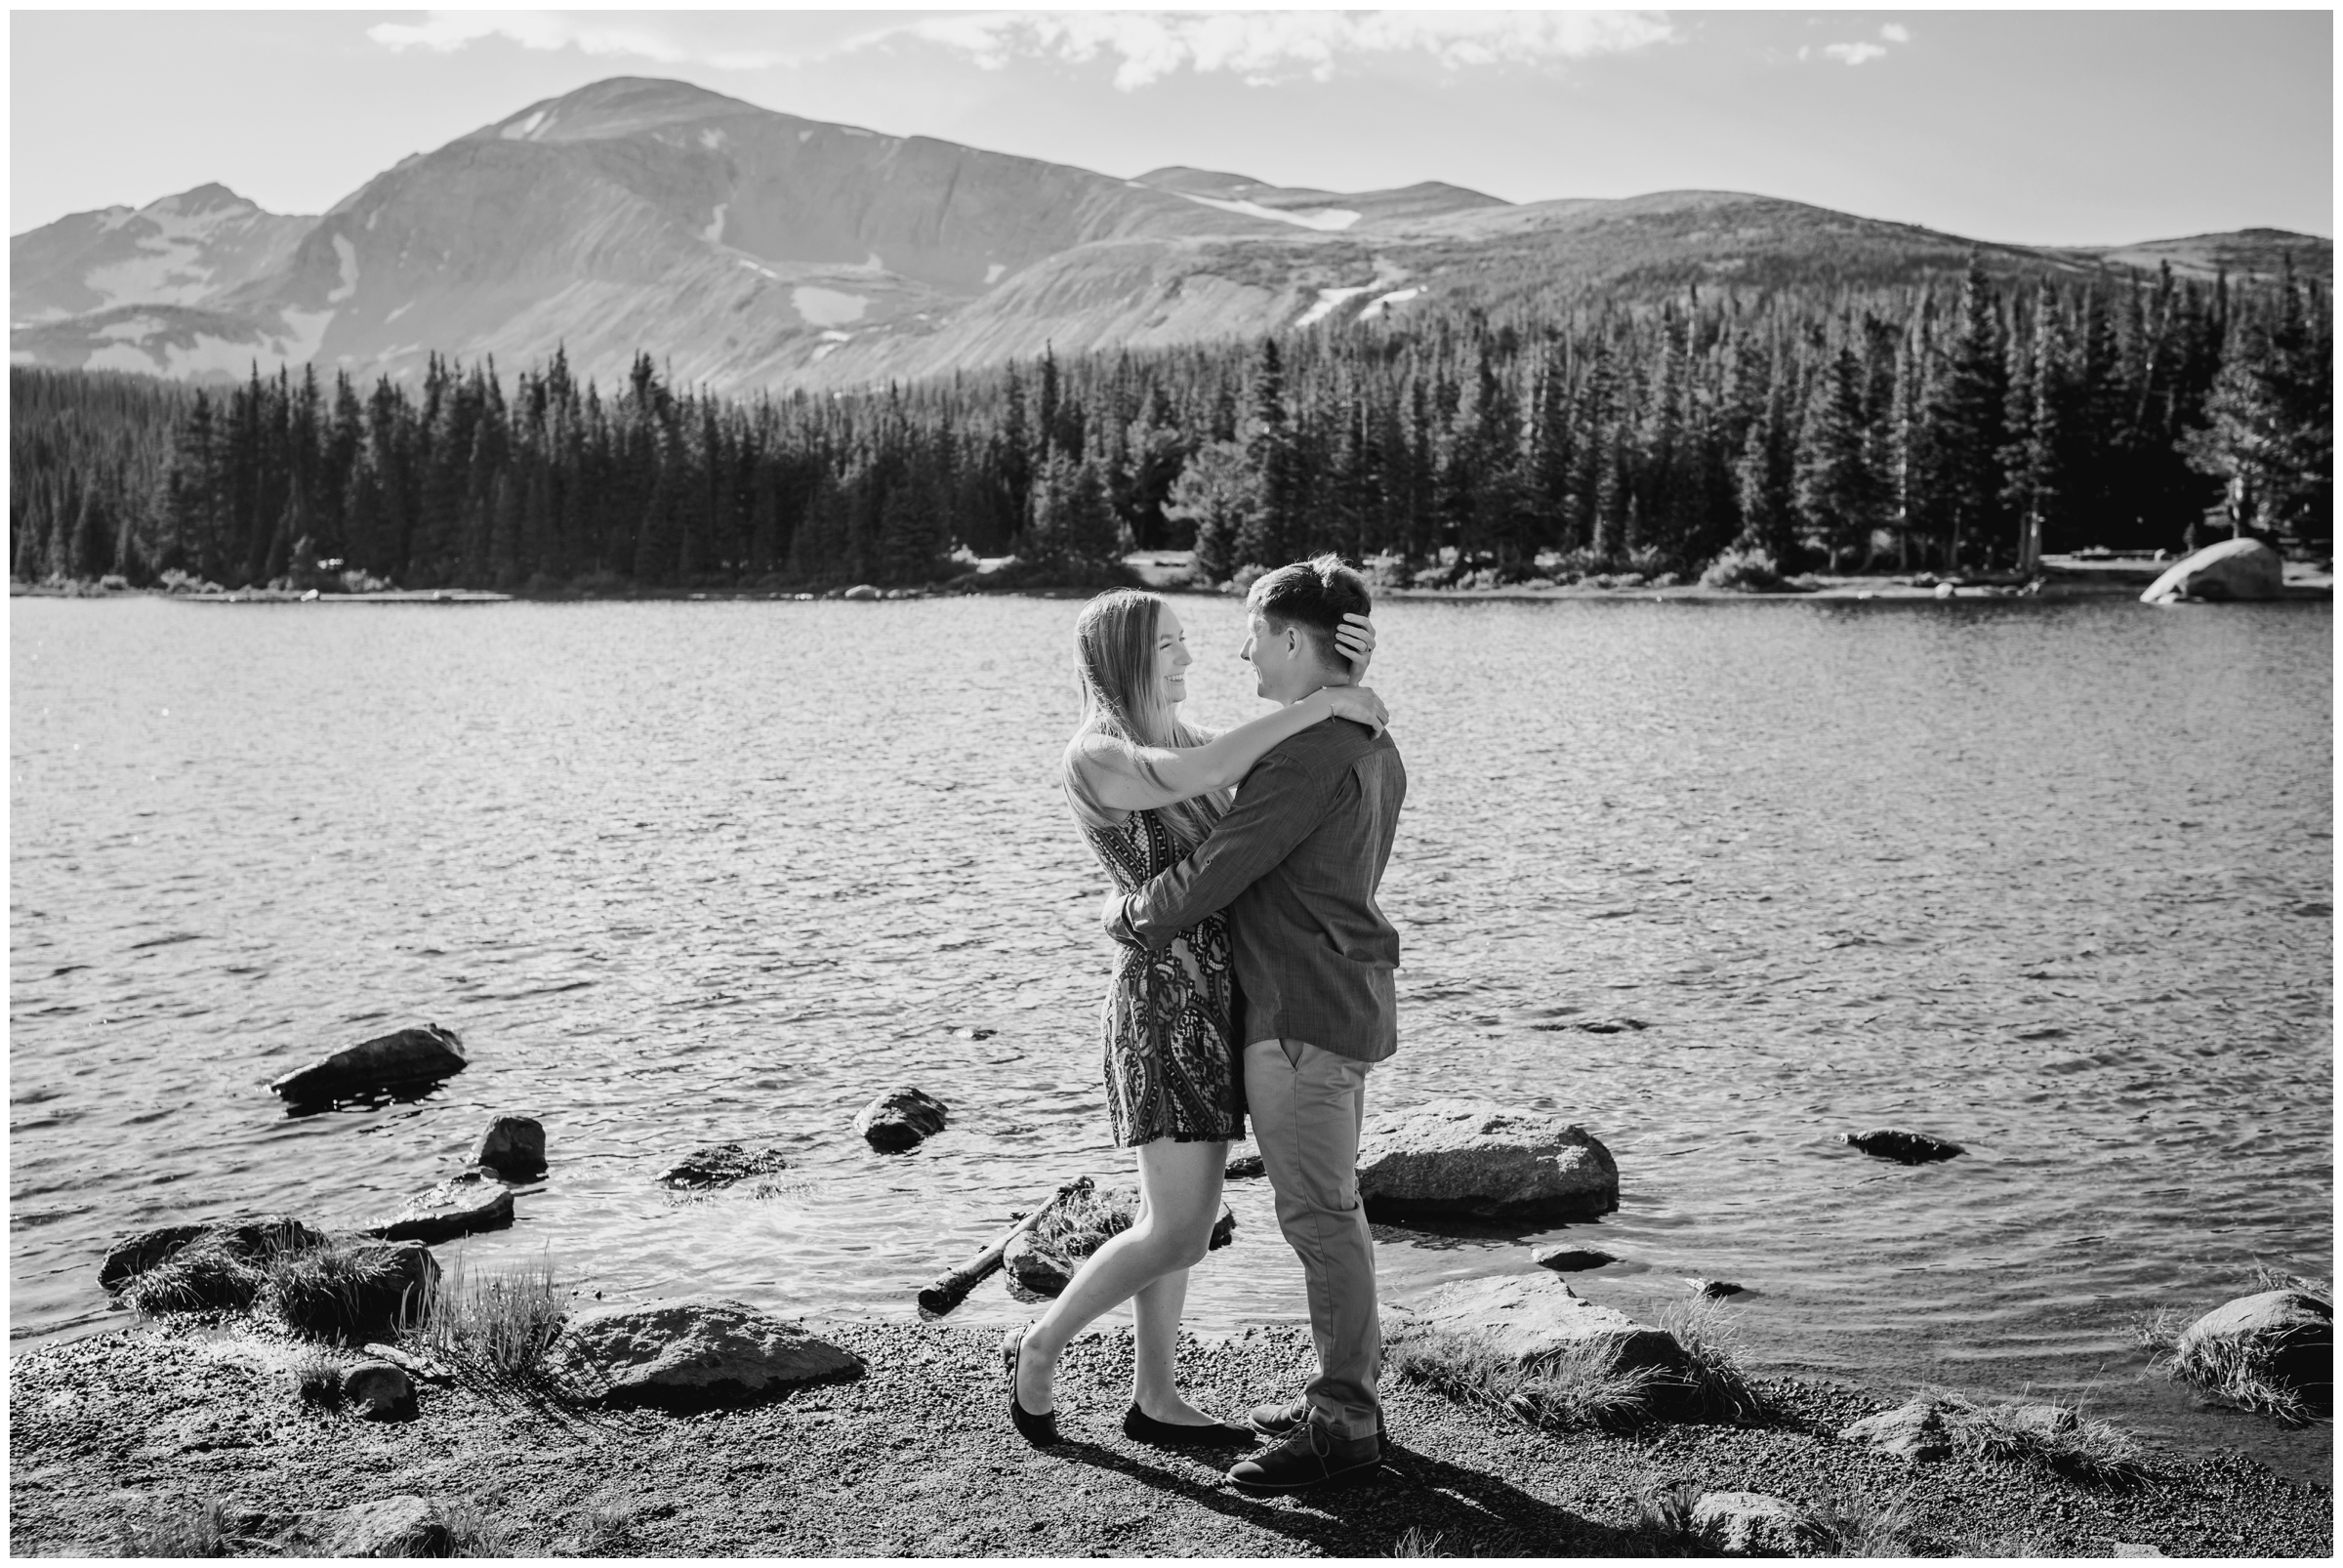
(1017, 1139), (1228, 1421)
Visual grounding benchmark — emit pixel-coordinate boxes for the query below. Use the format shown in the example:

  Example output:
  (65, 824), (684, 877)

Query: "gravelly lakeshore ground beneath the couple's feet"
(10, 1320), (2336, 1556)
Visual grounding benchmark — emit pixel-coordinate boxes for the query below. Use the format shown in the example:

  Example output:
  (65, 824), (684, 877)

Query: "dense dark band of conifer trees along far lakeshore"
(10, 263), (2333, 591)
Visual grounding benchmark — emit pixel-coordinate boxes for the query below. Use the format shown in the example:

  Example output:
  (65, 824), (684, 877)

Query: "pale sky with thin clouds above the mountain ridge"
(10, 10), (2333, 244)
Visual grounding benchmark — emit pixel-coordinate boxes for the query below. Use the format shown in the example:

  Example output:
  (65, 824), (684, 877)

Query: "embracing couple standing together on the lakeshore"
(1003, 556), (1408, 1491)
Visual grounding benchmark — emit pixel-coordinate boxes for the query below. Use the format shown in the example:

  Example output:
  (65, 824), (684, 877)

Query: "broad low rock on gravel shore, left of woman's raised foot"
(549, 1297), (862, 1409)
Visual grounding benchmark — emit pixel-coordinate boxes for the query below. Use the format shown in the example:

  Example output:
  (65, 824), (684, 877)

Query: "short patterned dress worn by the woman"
(1083, 811), (1244, 1148)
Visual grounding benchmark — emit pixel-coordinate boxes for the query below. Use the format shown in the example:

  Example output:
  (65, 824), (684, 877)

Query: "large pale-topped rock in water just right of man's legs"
(1359, 1099), (1619, 1221)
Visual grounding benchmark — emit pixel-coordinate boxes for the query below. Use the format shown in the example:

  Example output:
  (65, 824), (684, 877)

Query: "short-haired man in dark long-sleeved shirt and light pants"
(1108, 556), (1408, 1491)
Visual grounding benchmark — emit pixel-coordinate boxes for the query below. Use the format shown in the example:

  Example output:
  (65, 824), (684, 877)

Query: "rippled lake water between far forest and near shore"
(10, 590), (2333, 1476)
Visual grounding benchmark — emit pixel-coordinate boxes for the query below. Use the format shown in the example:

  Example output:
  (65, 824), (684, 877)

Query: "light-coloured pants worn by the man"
(1244, 1041), (1382, 1437)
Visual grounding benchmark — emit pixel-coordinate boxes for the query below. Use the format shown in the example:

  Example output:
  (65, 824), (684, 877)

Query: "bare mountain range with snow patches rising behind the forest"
(10, 77), (2333, 392)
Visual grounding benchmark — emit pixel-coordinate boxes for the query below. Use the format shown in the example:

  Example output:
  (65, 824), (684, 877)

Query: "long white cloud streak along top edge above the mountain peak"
(365, 12), (1675, 92)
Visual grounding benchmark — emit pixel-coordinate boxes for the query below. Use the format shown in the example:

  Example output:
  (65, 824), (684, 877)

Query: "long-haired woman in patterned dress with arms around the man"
(1001, 589), (1387, 1446)
